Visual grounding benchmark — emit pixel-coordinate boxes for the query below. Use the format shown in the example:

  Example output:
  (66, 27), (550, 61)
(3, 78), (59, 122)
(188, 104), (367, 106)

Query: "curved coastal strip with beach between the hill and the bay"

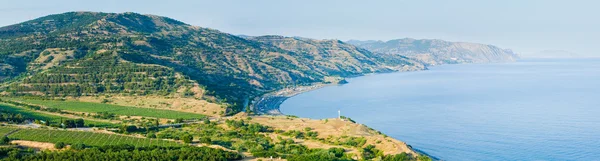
(250, 83), (337, 115)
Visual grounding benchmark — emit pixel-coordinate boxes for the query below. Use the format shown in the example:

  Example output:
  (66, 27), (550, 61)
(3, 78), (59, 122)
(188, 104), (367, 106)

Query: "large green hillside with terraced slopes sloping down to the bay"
(0, 12), (423, 112)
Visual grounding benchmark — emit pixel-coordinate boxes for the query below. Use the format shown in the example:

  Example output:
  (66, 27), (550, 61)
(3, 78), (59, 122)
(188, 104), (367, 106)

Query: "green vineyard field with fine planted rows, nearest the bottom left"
(5, 127), (182, 147)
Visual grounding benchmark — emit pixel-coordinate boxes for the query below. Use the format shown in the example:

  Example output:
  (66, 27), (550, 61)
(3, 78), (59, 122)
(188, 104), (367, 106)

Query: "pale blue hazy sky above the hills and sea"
(0, 0), (600, 56)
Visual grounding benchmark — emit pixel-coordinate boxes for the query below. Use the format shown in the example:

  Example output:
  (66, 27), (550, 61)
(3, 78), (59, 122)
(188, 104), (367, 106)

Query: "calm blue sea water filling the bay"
(281, 59), (600, 161)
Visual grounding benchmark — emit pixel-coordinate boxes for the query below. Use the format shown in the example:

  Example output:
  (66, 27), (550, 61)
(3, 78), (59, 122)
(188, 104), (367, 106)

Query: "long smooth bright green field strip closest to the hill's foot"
(12, 99), (205, 119)
